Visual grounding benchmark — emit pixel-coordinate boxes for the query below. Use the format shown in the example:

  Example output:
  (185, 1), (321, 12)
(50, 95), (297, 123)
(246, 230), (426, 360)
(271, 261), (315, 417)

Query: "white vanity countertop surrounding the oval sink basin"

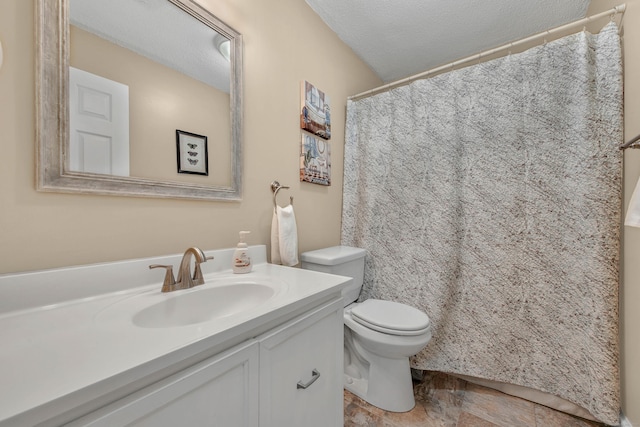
(0, 247), (350, 426)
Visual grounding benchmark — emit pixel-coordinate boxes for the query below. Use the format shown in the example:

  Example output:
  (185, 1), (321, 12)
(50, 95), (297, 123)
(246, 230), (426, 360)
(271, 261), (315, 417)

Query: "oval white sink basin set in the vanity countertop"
(132, 282), (275, 328)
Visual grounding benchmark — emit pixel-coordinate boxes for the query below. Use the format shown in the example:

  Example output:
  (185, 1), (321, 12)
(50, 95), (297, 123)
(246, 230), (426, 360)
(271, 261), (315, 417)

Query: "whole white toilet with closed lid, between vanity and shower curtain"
(300, 246), (431, 412)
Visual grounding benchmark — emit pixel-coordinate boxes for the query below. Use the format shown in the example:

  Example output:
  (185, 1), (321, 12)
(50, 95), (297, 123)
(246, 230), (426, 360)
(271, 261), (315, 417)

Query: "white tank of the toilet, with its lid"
(300, 246), (367, 306)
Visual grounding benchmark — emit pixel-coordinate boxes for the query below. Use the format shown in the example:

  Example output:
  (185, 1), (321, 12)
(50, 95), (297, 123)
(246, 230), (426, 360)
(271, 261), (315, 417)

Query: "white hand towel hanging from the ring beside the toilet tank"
(271, 205), (298, 266)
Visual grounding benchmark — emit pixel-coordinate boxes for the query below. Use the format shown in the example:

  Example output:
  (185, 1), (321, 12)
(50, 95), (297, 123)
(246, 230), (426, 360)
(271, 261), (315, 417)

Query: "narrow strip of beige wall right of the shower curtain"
(588, 0), (640, 426)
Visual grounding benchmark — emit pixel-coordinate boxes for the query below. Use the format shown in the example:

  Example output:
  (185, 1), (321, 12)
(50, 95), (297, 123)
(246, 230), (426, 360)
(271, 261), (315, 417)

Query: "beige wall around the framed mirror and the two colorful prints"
(0, 0), (381, 273)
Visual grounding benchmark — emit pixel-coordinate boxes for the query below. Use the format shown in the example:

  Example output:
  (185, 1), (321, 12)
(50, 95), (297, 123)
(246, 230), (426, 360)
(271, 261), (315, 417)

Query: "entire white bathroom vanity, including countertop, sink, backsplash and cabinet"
(0, 245), (351, 427)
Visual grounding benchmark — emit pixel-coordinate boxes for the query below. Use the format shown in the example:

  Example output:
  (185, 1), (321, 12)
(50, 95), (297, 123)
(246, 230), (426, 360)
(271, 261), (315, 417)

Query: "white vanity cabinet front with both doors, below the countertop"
(68, 298), (343, 427)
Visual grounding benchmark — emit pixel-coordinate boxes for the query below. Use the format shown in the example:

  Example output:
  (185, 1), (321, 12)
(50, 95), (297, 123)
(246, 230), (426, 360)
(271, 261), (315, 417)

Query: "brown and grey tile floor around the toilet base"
(344, 372), (604, 427)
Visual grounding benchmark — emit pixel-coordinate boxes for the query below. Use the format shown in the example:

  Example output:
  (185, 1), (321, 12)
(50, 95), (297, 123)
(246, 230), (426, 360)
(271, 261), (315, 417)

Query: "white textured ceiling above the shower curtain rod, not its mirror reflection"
(305, 0), (590, 82)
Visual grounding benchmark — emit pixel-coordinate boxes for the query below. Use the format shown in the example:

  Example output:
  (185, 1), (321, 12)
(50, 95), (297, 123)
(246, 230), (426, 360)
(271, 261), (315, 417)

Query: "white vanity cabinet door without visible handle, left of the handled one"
(69, 341), (259, 427)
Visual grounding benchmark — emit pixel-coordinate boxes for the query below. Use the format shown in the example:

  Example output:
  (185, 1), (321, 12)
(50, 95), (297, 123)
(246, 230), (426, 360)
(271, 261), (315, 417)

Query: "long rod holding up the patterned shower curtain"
(348, 3), (627, 101)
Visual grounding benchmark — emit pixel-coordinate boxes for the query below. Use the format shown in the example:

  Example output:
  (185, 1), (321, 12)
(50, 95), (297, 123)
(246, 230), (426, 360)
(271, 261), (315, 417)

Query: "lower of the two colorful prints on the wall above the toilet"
(300, 133), (331, 185)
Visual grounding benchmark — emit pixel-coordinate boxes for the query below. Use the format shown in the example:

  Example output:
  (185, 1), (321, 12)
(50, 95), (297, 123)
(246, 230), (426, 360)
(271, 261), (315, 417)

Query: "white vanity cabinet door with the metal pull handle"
(260, 298), (343, 427)
